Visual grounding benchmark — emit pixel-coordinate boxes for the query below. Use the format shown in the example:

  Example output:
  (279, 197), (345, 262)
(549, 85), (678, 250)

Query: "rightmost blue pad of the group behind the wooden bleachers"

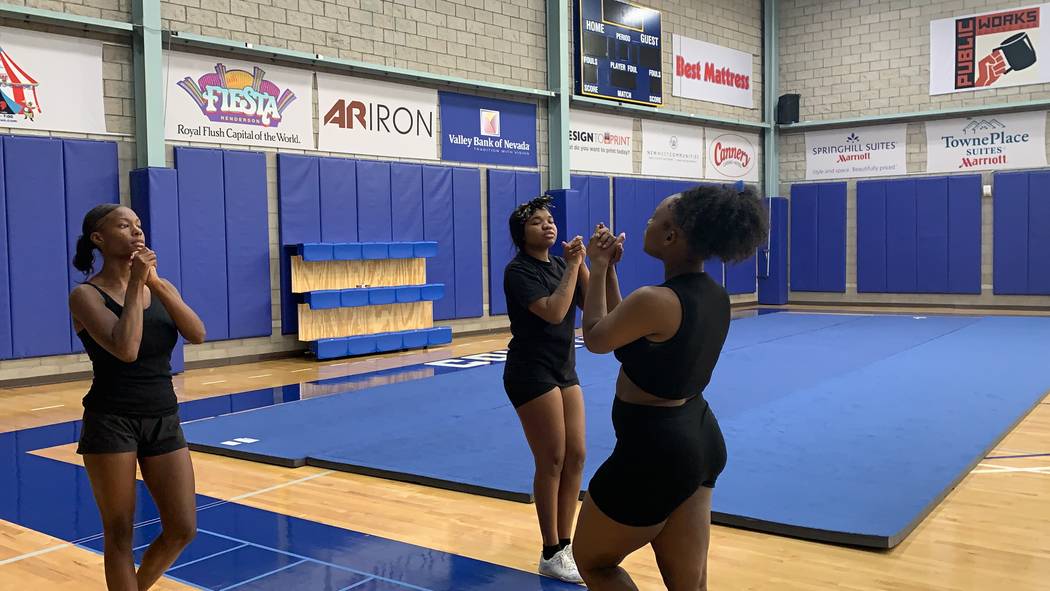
(451, 168), (485, 318)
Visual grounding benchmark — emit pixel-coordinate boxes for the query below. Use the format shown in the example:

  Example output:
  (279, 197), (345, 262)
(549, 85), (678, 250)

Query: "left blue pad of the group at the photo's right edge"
(992, 172), (1028, 295)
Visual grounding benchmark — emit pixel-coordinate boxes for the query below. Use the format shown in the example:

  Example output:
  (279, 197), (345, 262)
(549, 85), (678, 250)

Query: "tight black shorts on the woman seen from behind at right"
(587, 396), (727, 527)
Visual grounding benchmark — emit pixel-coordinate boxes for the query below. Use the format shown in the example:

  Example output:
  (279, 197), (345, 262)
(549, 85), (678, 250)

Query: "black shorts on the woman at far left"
(77, 409), (186, 458)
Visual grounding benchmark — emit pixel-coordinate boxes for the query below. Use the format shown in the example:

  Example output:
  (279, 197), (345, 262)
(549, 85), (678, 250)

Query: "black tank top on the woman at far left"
(77, 283), (179, 417)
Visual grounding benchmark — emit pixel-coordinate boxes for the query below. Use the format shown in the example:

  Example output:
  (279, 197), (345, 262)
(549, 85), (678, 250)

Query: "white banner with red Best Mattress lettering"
(671, 35), (755, 109)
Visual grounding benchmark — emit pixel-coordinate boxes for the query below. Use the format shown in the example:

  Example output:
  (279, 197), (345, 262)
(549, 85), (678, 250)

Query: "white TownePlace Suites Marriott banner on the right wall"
(926, 111), (1047, 172)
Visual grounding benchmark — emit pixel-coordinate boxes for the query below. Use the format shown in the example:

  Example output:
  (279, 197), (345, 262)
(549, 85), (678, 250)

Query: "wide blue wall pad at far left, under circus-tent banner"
(3, 135), (69, 357)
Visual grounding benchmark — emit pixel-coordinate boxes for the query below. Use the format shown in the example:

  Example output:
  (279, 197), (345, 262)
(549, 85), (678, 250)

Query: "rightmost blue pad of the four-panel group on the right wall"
(948, 174), (983, 294)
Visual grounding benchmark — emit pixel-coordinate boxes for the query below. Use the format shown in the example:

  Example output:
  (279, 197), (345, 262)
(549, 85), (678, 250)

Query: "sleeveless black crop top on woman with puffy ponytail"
(615, 273), (730, 400)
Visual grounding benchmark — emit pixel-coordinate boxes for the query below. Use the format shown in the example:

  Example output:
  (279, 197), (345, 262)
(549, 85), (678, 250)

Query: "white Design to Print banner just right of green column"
(569, 110), (634, 174)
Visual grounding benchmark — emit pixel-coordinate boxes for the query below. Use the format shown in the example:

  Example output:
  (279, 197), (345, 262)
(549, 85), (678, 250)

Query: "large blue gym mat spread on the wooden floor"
(185, 313), (1050, 548)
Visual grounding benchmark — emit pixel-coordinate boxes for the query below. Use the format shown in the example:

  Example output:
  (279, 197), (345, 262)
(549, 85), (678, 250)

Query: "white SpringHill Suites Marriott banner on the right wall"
(805, 124), (908, 181)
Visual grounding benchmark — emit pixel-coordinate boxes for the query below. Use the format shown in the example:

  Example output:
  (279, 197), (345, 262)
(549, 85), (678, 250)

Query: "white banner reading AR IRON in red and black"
(317, 73), (438, 160)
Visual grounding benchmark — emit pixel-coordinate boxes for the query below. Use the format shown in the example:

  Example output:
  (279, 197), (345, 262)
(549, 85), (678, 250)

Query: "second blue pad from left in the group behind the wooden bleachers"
(318, 159), (357, 242)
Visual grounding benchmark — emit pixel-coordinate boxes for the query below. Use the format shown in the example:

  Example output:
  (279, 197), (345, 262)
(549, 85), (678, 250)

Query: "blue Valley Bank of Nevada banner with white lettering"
(438, 92), (537, 168)
